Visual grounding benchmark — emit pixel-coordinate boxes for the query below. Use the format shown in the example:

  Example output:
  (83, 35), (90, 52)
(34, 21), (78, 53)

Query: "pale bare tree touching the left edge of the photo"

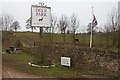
(0, 13), (14, 31)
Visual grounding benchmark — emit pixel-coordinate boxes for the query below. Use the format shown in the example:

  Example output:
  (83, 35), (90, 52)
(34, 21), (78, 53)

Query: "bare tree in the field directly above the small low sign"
(57, 15), (69, 43)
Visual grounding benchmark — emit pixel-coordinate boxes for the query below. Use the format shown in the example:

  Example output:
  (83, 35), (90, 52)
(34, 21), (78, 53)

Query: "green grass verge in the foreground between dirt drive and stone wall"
(3, 53), (80, 78)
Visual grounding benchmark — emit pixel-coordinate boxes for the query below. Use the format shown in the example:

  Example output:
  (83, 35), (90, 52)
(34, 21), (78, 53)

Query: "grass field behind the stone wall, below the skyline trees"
(15, 32), (116, 48)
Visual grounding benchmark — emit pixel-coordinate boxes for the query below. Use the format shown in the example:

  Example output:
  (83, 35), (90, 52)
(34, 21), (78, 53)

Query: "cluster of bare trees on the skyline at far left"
(0, 13), (21, 31)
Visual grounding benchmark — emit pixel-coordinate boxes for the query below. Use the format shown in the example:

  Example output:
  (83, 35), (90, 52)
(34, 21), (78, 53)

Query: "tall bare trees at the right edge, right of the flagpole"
(101, 8), (120, 48)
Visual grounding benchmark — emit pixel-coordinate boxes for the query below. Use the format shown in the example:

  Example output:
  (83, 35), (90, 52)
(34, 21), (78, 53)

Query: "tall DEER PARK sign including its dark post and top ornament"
(31, 2), (51, 64)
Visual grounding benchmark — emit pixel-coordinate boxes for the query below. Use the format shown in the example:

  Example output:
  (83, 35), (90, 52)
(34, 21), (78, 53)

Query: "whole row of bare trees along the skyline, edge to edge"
(0, 8), (120, 47)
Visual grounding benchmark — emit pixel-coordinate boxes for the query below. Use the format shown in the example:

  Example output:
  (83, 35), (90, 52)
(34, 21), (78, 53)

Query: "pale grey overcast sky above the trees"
(0, 0), (119, 32)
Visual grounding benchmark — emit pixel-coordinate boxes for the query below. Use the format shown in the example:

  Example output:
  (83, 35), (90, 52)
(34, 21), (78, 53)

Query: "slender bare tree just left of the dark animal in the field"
(70, 14), (79, 43)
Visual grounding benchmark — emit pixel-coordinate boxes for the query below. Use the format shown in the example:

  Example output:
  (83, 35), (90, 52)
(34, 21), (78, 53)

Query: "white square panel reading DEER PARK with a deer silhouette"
(31, 6), (51, 27)
